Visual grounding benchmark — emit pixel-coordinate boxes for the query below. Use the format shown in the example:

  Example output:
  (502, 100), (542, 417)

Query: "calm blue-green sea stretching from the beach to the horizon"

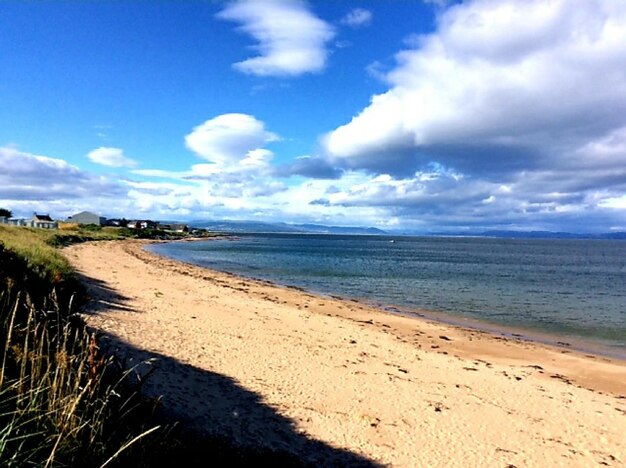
(149, 234), (626, 357)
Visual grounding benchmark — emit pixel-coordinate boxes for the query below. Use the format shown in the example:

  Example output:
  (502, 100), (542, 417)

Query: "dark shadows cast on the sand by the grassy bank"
(81, 276), (381, 467)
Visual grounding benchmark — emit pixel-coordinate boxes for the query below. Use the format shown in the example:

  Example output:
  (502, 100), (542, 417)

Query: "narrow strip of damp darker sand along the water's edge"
(144, 236), (626, 364)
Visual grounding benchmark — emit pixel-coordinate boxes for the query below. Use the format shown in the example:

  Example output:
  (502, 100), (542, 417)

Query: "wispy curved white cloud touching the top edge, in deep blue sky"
(217, 0), (335, 76)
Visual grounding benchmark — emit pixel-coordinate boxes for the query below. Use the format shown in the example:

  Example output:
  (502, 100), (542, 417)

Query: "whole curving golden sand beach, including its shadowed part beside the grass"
(66, 242), (626, 466)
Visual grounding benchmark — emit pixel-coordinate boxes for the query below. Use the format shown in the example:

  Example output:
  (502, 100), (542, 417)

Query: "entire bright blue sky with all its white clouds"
(0, 0), (626, 233)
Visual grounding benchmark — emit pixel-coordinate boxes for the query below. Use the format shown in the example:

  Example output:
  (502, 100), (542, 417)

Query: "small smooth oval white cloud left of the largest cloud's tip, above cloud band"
(185, 114), (279, 165)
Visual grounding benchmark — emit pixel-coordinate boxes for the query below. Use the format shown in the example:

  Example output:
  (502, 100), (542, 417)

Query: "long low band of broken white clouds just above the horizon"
(0, 142), (626, 231)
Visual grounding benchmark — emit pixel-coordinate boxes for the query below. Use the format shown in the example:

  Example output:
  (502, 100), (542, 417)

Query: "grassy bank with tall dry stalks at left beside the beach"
(0, 226), (163, 466)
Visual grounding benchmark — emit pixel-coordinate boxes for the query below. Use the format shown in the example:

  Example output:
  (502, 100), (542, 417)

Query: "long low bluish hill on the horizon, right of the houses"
(189, 220), (387, 235)
